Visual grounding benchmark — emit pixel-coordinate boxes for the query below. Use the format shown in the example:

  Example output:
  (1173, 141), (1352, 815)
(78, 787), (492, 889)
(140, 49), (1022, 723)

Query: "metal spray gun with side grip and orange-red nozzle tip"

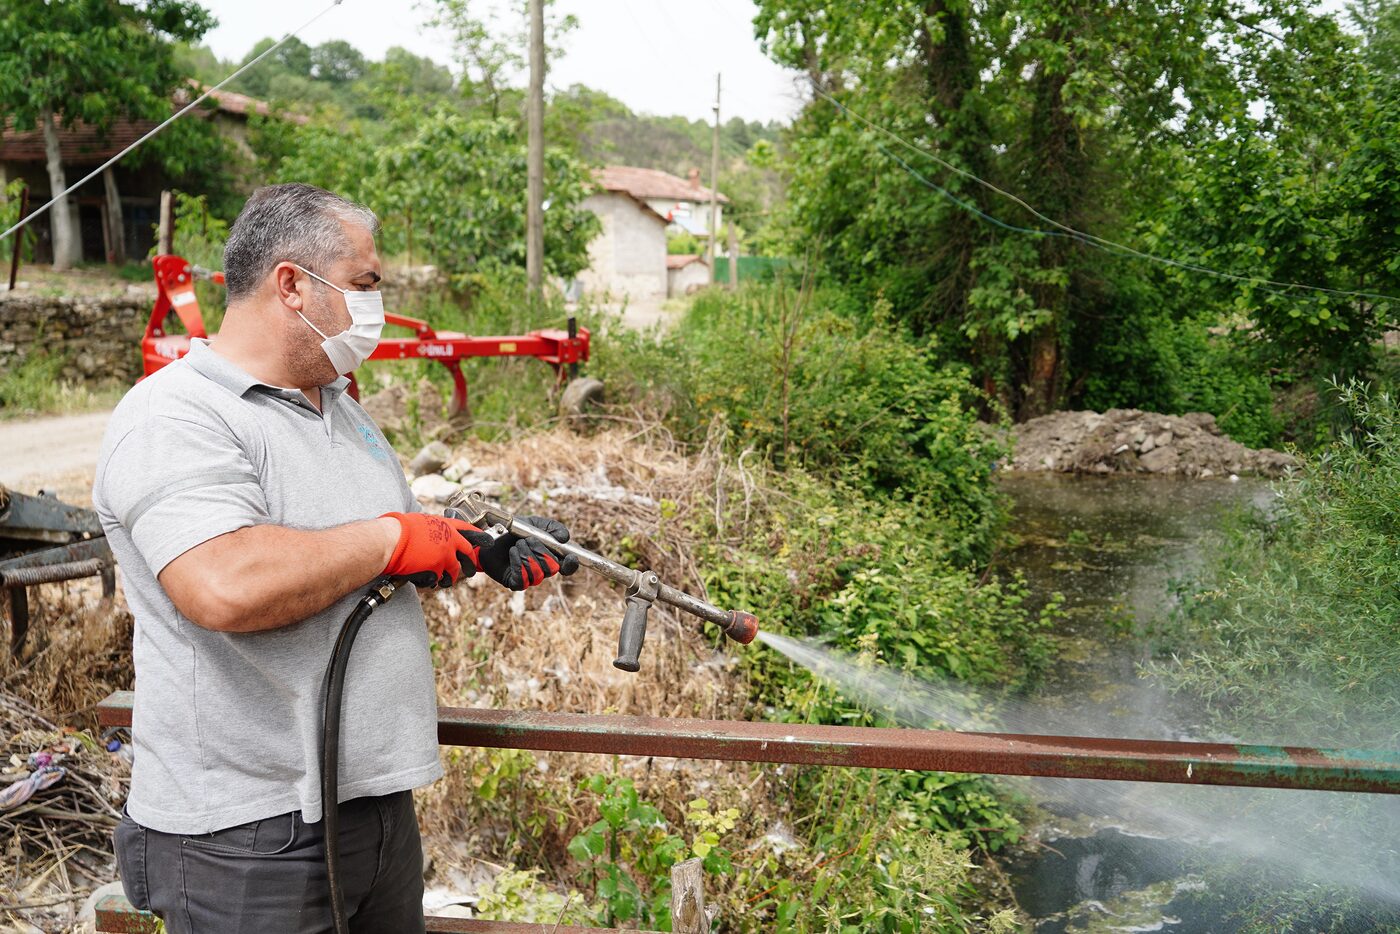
(448, 492), (759, 671)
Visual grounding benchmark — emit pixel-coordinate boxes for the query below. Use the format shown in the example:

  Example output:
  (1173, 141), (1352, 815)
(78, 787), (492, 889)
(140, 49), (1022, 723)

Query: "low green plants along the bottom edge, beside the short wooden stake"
(560, 769), (1014, 934)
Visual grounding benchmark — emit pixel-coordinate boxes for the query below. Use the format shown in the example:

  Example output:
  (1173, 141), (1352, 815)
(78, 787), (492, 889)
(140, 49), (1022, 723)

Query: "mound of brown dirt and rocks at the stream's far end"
(1007, 409), (1295, 478)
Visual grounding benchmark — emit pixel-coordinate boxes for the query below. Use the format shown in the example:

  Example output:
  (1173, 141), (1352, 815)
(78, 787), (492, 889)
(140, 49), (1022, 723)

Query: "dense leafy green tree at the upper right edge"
(1142, 10), (1400, 378)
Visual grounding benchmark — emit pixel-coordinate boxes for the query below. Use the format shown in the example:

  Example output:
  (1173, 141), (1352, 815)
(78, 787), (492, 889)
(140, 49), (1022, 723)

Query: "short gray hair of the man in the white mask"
(224, 182), (379, 301)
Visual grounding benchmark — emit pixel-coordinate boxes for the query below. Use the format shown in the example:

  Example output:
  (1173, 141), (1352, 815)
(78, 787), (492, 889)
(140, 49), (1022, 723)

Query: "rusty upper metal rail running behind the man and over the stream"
(98, 692), (1400, 794)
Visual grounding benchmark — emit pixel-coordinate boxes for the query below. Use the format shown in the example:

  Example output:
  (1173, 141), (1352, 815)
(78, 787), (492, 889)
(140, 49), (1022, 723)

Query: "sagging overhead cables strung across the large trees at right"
(812, 84), (1400, 302)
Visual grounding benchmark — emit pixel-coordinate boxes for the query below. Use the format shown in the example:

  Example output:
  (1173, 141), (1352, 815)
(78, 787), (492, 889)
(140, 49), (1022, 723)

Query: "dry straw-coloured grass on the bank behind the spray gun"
(420, 427), (783, 885)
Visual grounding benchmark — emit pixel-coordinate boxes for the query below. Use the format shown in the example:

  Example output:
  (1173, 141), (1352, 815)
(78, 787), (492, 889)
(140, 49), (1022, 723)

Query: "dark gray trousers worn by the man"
(113, 791), (423, 934)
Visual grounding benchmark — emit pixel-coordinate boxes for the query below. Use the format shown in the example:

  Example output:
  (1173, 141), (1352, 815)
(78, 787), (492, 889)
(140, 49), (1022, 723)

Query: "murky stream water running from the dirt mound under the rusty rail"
(1000, 475), (1400, 934)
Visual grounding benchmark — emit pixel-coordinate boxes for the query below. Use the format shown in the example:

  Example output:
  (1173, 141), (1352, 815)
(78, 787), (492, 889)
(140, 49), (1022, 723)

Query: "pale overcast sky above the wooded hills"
(202, 0), (801, 120)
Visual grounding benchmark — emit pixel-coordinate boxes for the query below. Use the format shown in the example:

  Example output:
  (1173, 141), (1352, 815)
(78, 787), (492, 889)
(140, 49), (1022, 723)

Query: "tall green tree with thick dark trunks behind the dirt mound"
(755, 0), (1377, 417)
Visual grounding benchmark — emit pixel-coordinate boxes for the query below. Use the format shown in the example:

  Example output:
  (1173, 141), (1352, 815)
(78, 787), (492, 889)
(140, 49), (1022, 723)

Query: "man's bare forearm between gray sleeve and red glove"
(160, 518), (399, 633)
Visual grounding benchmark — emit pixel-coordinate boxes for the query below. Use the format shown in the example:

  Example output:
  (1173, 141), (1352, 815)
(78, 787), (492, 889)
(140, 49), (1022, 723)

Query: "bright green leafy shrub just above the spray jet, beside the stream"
(697, 471), (1058, 694)
